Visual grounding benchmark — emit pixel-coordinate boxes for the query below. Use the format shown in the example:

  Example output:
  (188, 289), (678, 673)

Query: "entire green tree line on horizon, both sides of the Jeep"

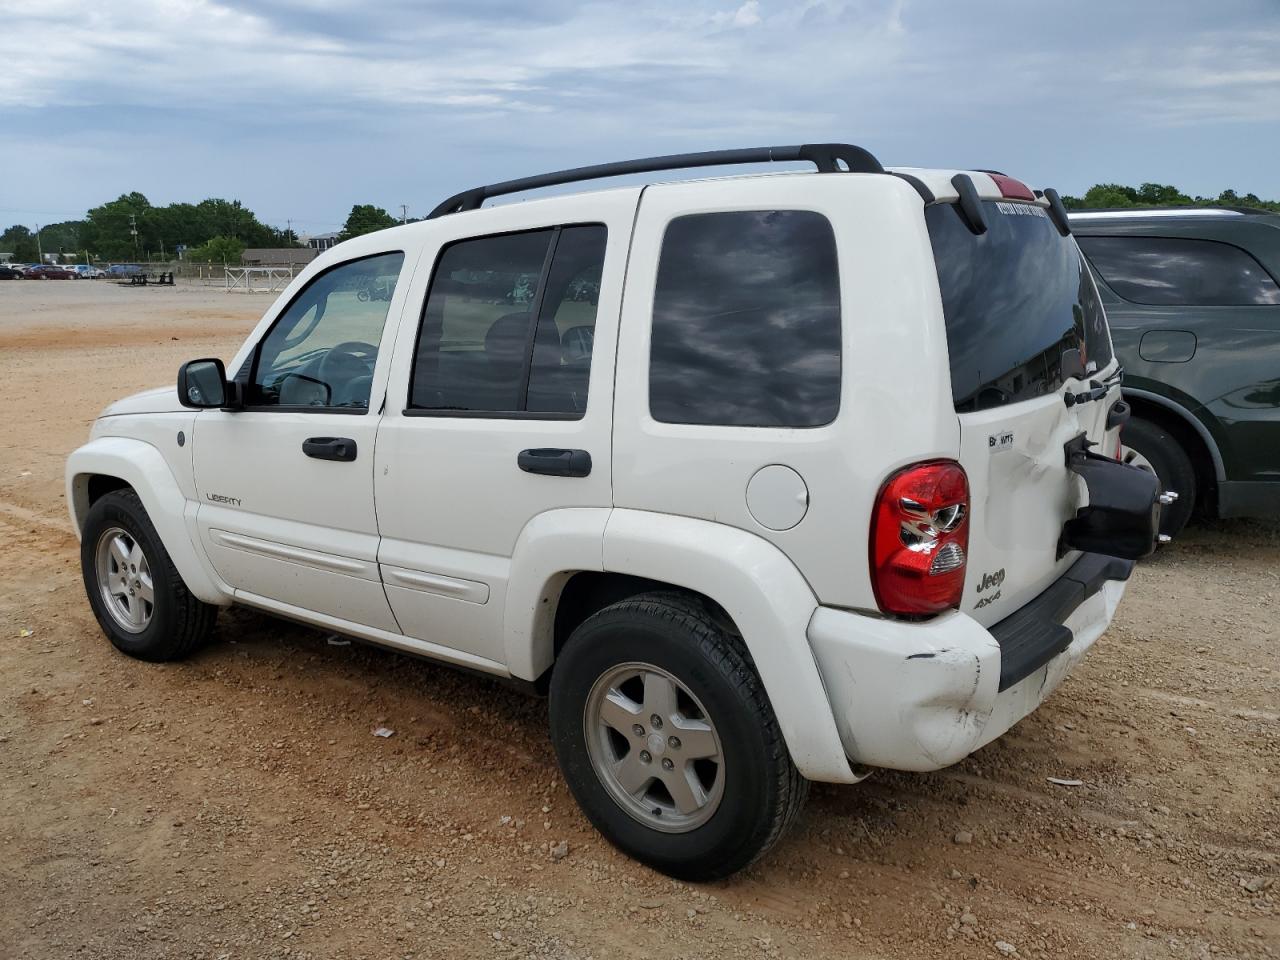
(0, 183), (1280, 264)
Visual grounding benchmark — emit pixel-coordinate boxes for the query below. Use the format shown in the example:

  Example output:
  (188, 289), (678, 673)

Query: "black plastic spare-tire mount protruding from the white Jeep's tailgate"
(1057, 434), (1178, 559)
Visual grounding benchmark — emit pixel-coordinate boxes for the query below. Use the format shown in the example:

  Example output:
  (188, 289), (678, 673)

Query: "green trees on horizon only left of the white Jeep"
(0, 192), (399, 264)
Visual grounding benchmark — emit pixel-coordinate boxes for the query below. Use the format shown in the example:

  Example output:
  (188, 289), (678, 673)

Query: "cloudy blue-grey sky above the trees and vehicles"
(0, 0), (1280, 233)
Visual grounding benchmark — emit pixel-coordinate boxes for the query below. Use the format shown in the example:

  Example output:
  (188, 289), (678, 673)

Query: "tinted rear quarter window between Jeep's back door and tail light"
(649, 210), (841, 428)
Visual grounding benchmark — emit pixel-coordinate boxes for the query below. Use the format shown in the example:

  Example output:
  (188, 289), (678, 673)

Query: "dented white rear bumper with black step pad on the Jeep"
(809, 554), (1132, 771)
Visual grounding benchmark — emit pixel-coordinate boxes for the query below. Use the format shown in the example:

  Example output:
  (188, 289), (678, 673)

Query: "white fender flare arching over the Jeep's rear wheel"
(504, 509), (860, 782)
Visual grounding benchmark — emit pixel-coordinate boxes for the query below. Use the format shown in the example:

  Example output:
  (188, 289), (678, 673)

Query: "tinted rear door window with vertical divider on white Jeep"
(408, 224), (607, 417)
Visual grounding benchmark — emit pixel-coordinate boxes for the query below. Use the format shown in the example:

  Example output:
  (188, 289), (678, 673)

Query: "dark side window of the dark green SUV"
(1076, 237), (1280, 307)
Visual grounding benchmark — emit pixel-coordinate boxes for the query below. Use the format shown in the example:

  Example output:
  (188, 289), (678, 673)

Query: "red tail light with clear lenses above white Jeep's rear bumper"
(870, 460), (969, 616)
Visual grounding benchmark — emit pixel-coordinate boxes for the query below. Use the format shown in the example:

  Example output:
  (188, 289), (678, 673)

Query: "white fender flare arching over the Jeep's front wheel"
(65, 436), (232, 605)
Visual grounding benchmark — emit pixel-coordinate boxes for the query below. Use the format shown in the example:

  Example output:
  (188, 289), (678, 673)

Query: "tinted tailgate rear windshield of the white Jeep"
(924, 200), (1111, 412)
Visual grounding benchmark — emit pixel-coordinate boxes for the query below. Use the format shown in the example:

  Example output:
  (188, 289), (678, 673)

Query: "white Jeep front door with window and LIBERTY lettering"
(192, 252), (407, 634)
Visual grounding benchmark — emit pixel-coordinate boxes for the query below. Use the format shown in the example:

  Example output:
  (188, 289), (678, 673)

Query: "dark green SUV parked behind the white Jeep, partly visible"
(1070, 207), (1280, 534)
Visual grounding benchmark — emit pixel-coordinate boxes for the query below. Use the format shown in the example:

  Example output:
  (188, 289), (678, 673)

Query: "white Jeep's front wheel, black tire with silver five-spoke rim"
(81, 489), (218, 663)
